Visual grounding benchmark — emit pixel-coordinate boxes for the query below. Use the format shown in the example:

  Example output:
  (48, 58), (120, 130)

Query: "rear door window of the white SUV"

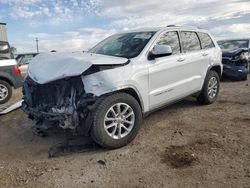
(181, 31), (201, 53)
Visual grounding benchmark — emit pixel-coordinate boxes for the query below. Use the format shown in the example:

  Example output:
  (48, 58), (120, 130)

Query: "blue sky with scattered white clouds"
(0, 0), (250, 53)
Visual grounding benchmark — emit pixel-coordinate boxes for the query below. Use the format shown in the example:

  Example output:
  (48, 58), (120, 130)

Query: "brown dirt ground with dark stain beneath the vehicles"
(0, 81), (250, 188)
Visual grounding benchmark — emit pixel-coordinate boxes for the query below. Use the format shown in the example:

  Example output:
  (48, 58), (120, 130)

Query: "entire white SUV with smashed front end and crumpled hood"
(22, 26), (222, 148)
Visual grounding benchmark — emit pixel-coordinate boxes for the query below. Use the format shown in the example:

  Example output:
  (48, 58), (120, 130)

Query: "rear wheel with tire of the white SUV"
(197, 70), (220, 105)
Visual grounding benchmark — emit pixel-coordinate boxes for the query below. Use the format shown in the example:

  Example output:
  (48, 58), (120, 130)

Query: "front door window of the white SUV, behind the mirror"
(157, 31), (181, 54)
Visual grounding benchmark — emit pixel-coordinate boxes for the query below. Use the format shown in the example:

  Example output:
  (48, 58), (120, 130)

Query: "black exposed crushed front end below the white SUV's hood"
(22, 76), (95, 130)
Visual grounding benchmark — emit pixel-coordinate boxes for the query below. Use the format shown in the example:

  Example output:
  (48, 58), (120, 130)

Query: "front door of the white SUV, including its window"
(149, 31), (188, 109)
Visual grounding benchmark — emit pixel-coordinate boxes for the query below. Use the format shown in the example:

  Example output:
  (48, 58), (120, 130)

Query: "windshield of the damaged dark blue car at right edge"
(218, 40), (249, 50)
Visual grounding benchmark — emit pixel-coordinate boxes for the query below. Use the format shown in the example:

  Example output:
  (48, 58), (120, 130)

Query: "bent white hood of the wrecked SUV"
(28, 52), (128, 84)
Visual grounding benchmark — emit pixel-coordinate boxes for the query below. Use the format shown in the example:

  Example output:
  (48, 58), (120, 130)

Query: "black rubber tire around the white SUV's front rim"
(91, 93), (142, 149)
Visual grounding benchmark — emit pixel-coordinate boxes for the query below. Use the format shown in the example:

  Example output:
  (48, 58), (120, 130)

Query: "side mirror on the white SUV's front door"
(149, 45), (173, 60)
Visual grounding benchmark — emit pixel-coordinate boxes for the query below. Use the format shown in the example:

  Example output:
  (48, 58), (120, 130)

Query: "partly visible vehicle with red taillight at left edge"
(0, 23), (22, 104)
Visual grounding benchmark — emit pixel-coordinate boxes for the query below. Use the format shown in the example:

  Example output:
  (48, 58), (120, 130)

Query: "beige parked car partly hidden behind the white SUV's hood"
(16, 53), (38, 77)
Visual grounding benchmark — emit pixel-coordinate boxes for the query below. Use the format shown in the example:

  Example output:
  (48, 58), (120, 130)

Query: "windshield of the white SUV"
(89, 32), (155, 58)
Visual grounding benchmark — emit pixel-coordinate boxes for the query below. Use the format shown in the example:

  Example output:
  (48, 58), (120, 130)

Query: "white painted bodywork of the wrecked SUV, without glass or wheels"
(29, 27), (222, 112)
